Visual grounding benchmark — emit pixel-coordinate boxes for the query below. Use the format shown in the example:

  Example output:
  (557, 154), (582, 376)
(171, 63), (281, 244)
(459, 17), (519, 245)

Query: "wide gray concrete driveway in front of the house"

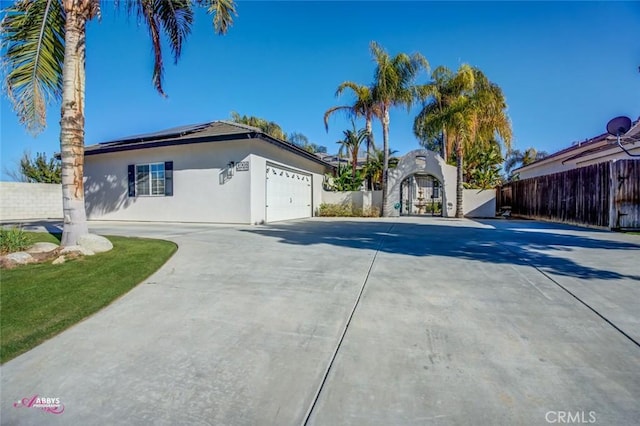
(0, 218), (640, 425)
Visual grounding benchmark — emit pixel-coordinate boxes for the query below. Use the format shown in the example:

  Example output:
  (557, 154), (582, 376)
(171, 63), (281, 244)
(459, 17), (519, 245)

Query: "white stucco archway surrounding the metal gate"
(385, 149), (456, 217)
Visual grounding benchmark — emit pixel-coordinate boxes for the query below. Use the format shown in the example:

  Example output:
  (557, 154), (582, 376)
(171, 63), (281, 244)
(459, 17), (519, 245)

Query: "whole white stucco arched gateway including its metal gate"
(385, 149), (456, 217)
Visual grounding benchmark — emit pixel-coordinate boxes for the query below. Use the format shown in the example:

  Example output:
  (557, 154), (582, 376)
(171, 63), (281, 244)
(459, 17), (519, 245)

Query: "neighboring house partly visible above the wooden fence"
(513, 115), (640, 179)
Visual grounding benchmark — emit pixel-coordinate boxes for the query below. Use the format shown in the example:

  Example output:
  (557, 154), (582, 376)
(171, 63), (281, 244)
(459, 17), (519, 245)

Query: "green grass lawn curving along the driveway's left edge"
(0, 233), (177, 363)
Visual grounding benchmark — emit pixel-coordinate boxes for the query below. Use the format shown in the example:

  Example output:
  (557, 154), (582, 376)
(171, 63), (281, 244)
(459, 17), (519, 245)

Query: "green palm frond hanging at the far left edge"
(0, 0), (65, 134)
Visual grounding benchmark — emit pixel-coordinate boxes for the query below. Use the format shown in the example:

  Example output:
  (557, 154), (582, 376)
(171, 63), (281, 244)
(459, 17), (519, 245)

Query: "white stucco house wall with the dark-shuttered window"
(85, 141), (250, 223)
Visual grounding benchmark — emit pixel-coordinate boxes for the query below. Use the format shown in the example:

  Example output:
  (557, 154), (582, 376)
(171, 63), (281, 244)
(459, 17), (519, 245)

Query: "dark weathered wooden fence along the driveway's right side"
(496, 160), (640, 229)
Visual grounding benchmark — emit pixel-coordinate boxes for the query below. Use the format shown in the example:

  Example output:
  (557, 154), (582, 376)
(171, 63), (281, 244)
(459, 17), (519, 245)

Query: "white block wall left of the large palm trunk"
(0, 182), (62, 221)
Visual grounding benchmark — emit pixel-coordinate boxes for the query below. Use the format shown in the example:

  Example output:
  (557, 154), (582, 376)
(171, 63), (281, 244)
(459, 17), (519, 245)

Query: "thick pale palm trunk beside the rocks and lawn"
(60, 0), (92, 246)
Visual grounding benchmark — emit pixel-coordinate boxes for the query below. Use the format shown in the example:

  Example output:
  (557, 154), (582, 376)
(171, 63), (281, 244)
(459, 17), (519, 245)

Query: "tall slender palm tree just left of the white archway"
(370, 41), (429, 216)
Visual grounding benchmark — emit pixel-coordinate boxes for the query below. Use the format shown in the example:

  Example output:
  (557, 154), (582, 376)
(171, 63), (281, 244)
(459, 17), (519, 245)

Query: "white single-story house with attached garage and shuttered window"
(84, 121), (332, 224)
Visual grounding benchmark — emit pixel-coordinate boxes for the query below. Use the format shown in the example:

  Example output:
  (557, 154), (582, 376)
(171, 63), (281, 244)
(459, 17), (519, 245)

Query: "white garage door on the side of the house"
(266, 163), (311, 222)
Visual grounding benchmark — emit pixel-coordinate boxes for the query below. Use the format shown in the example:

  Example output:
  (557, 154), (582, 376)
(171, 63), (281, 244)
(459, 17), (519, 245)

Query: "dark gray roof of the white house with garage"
(84, 120), (332, 167)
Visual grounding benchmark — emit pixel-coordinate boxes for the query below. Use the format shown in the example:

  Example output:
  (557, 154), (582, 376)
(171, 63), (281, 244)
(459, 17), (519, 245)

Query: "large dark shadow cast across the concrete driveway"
(244, 218), (640, 281)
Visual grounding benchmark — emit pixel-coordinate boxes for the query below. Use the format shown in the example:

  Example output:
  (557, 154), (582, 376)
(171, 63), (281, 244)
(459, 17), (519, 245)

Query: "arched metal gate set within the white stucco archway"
(400, 173), (442, 216)
